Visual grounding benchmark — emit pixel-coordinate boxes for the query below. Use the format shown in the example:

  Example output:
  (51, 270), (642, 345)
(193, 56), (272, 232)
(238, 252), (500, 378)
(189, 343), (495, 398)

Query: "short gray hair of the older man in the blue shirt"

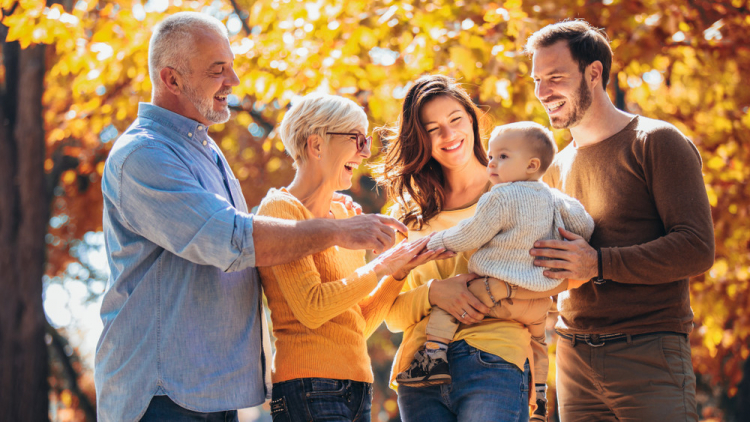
(148, 12), (228, 89)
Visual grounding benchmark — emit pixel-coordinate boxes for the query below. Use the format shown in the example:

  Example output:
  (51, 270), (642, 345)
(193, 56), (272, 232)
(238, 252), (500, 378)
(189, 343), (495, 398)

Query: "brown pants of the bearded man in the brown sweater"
(556, 333), (698, 422)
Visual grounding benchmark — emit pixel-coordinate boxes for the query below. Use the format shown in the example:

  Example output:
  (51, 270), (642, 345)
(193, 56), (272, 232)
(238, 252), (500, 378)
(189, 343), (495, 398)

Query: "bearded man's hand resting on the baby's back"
(529, 228), (599, 280)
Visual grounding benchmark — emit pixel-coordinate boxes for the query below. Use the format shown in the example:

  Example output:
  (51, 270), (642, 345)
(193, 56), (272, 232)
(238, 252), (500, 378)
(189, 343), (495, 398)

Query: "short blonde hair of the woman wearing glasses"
(279, 94), (369, 167)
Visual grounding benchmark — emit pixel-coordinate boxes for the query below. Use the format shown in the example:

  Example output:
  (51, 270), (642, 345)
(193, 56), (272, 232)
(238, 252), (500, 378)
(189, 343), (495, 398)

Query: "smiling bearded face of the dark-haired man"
(531, 40), (592, 129)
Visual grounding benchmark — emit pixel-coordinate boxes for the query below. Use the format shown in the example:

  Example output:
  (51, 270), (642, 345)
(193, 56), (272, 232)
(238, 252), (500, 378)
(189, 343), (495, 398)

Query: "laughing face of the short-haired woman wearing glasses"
(321, 126), (371, 191)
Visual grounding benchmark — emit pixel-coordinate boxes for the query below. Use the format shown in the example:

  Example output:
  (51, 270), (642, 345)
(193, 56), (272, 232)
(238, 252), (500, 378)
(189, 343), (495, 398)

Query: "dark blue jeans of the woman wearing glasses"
(271, 378), (372, 422)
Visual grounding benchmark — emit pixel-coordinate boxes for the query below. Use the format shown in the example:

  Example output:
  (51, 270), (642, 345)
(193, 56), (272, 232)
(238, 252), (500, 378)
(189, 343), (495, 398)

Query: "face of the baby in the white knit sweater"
(487, 134), (539, 185)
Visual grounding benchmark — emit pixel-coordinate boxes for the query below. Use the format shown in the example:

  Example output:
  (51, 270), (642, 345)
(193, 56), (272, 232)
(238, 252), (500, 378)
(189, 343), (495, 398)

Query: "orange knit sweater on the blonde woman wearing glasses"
(258, 188), (403, 383)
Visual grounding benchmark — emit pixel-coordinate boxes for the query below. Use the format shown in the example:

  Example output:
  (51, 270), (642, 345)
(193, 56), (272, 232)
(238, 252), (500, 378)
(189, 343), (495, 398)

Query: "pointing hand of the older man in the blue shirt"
(333, 214), (408, 253)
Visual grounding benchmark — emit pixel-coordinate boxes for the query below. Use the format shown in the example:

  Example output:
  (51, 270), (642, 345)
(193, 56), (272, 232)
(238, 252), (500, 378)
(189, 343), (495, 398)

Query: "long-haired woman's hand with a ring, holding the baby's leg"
(429, 274), (490, 324)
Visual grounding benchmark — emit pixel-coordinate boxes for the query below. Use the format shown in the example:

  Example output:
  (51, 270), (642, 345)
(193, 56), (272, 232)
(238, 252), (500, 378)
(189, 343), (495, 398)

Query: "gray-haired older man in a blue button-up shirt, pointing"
(95, 13), (405, 421)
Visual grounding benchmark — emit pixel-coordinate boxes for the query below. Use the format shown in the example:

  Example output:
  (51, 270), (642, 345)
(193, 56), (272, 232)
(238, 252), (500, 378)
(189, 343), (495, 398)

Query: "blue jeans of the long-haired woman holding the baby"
(398, 340), (530, 422)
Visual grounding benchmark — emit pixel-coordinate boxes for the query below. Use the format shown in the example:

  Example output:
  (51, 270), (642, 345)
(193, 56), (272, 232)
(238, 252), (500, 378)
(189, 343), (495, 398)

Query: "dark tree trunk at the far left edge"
(0, 33), (49, 422)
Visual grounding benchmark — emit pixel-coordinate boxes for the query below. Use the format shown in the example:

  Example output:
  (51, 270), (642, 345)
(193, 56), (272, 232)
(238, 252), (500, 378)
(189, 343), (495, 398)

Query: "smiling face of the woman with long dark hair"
(419, 96), (476, 170)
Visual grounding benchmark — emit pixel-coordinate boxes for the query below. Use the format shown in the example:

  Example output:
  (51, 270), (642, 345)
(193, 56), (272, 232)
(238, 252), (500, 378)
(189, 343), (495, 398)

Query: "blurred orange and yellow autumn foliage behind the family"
(0, 0), (750, 417)
